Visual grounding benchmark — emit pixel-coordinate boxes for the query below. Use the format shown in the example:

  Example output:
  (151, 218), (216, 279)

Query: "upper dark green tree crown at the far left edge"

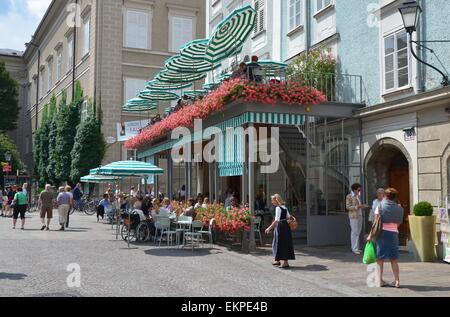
(0, 61), (19, 131)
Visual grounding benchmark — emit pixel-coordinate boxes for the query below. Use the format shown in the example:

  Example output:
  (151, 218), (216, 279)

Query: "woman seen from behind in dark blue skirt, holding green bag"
(367, 188), (404, 288)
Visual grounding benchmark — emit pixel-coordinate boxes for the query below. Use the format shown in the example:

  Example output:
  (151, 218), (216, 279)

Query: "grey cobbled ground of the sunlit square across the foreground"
(0, 213), (450, 297)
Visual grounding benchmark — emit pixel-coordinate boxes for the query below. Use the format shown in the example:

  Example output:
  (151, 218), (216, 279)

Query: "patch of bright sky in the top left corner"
(0, 0), (51, 51)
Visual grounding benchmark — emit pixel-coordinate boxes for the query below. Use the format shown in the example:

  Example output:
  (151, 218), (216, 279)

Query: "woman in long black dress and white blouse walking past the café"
(266, 194), (295, 269)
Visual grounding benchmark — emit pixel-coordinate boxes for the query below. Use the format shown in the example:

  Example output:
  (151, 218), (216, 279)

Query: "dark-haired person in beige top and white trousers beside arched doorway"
(345, 183), (365, 254)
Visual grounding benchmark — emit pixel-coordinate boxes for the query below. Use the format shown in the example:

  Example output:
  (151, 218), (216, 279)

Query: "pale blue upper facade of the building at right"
(282, 0), (450, 105)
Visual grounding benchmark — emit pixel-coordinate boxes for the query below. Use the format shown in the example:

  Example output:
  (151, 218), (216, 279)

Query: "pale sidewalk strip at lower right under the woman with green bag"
(253, 245), (450, 297)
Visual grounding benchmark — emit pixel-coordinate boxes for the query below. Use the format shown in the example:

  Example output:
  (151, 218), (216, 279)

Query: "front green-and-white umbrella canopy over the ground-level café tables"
(90, 161), (164, 177)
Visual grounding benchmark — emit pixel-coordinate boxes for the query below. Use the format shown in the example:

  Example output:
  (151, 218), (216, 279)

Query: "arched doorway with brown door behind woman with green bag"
(365, 139), (411, 246)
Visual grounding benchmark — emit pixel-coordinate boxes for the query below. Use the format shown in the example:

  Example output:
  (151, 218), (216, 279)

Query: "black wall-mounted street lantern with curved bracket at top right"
(399, 1), (449, 87)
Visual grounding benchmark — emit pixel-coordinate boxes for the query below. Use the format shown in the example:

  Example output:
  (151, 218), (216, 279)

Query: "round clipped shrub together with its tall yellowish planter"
(409, 201), (436, 262)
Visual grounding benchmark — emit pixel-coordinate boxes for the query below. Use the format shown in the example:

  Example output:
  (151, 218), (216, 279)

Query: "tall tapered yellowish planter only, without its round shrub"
(409, 216), (436, 262)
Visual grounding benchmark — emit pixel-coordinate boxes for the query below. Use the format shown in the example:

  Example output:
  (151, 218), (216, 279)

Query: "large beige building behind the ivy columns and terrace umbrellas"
(19, 0), (205, 173)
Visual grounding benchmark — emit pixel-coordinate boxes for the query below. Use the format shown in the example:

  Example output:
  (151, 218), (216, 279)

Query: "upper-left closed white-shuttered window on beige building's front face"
(125, 10), (149, 49)
